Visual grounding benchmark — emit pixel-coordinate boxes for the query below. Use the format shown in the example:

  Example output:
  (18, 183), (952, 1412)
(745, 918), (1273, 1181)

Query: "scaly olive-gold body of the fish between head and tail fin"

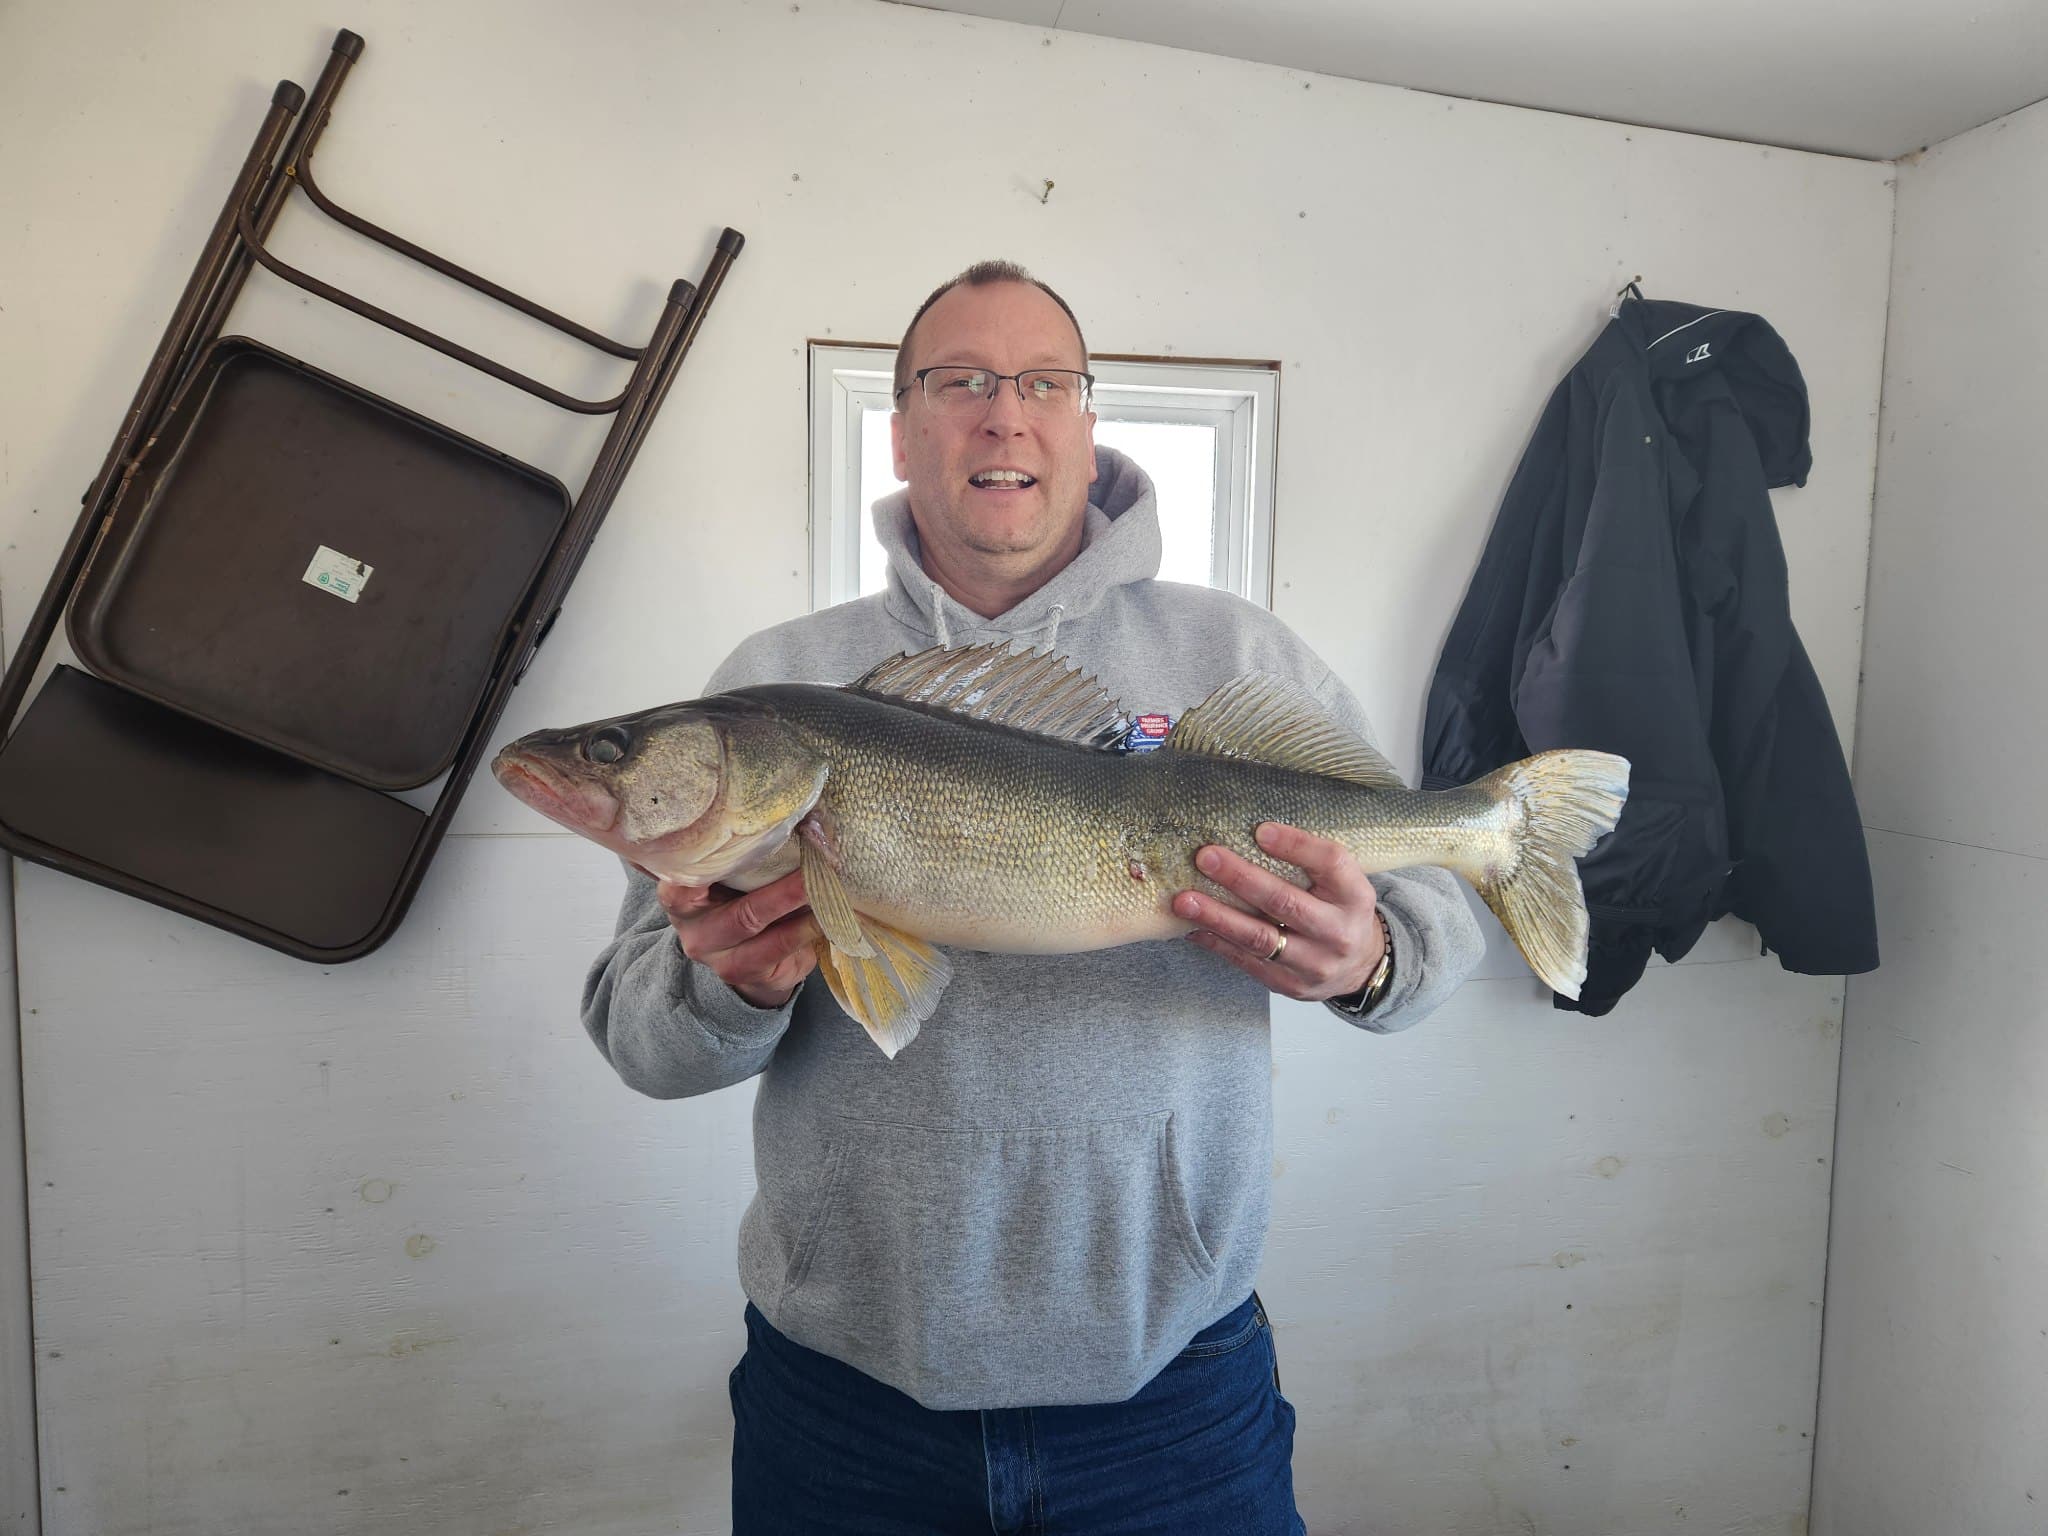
(741, 684), (1505, 954)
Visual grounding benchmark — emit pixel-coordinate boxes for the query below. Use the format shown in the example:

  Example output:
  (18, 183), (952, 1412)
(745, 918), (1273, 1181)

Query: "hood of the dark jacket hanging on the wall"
(1614, 299), (1812, 485)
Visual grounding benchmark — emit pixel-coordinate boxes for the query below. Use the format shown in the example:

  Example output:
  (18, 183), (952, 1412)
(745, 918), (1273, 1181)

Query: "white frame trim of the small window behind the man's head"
(811, 342), (1280, 610)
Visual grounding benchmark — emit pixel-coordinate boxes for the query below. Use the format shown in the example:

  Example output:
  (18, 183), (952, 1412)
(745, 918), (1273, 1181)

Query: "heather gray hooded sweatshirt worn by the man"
(584, 449), (1481, 1409)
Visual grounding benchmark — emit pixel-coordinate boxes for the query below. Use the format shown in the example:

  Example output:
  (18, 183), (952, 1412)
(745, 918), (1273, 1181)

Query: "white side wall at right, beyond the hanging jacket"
(1815, 96), (2048, 1536)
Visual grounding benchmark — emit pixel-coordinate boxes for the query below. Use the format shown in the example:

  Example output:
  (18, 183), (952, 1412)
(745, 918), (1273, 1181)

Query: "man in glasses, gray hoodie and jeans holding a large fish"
(584, 262), (1481, 1536)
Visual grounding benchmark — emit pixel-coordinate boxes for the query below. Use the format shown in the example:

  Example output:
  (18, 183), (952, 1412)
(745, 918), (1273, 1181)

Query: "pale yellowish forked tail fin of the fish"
(1473, 750), (1628, 997)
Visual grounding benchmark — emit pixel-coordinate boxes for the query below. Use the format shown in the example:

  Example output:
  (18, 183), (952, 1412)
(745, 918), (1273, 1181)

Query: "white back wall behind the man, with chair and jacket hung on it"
(0, 0), (1892, 1536)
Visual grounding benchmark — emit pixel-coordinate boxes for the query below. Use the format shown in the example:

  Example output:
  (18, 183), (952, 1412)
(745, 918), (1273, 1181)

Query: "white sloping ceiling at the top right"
(897, 0), (2048, 160)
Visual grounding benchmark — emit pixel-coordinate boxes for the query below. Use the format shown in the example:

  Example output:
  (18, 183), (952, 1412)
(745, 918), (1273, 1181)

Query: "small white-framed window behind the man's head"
(811, 342), (1280, 608)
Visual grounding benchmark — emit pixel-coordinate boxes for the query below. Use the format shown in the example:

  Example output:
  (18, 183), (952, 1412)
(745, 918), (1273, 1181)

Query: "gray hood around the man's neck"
(874, 438), (1161, 649)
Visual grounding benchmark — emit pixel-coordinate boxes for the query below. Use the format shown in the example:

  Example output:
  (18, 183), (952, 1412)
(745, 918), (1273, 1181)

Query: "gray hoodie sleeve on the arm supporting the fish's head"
(584, 651), (809, 1098)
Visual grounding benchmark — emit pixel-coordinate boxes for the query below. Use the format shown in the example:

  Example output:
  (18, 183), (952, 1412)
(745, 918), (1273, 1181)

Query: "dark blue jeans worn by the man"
(731, 1294), (1303, 1536)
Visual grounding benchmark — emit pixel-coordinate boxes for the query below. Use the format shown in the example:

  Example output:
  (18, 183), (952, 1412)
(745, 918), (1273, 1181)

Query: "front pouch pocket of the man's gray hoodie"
(780, 1110), (1217, 1401)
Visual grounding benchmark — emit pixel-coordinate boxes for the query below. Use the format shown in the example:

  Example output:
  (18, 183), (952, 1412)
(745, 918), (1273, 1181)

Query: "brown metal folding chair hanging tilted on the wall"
(0, 31), (743, 963)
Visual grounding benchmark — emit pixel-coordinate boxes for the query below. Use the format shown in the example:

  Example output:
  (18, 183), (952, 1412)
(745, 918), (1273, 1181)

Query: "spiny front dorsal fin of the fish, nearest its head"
(848, 641), (1130, 748)
